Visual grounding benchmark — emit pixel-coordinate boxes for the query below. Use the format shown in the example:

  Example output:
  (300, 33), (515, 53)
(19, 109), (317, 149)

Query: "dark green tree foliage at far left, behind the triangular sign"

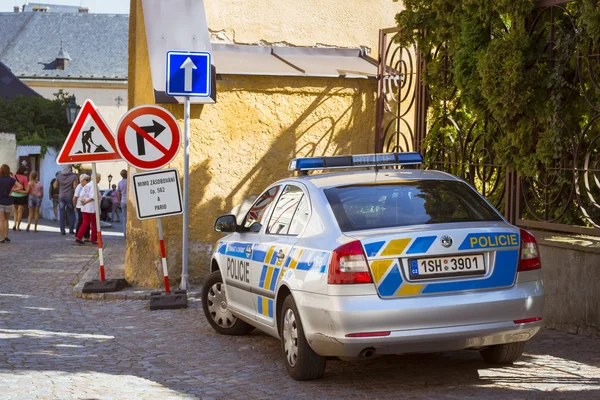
(0, 89), (71, 153)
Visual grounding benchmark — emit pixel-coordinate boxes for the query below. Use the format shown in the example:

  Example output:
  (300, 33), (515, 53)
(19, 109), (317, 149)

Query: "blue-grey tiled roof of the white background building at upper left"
(0, 13), (129, 80)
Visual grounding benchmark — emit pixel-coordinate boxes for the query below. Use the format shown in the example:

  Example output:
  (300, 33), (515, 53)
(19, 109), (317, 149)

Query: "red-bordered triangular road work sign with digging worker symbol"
(56, 99), (121, 164)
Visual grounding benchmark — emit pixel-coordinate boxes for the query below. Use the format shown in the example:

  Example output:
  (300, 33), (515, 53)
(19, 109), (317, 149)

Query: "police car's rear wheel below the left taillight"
(279, 294), (326, 381)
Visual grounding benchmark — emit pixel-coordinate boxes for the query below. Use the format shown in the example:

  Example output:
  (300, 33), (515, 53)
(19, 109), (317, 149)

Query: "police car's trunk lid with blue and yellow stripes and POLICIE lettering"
(346, 222), (520, 299)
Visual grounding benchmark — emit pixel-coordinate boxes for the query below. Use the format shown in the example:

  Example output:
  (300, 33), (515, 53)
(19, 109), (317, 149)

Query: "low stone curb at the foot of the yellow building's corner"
(73, 242), (202, 300)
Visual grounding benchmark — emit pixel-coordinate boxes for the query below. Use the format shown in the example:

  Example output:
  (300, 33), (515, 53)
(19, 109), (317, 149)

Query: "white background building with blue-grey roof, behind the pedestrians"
(0, 6), (129, 218)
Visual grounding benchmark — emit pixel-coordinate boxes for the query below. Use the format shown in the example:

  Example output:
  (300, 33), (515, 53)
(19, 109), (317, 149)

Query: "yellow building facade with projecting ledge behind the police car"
(126, 0), (401, 286)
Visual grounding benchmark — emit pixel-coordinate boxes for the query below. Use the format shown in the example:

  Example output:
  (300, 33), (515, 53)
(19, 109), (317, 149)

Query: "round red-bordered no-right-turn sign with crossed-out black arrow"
(117, 105), (181, 169)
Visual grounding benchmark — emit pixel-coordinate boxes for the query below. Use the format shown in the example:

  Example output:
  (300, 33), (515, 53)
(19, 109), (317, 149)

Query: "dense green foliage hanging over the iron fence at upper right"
(396, 0), (600, 177)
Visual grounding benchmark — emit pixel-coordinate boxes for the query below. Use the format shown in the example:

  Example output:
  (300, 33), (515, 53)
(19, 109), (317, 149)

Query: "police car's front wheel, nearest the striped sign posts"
(202, 271), (254, 336)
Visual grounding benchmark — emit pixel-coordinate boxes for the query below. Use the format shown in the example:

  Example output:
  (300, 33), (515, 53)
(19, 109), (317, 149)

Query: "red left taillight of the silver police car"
(327, 240), (373, 285)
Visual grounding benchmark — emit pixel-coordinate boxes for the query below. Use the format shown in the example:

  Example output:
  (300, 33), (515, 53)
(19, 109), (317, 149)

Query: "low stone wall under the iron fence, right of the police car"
(535, 232), (600, 336)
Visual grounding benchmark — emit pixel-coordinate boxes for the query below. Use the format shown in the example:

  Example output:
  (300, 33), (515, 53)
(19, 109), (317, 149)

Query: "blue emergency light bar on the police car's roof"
(288, 153), (423, 171)
